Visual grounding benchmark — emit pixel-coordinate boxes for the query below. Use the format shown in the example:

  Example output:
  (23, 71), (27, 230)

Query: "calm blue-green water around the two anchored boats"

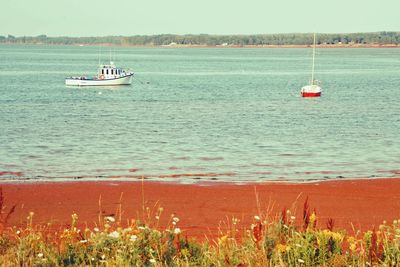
(0, 45), (400, 183)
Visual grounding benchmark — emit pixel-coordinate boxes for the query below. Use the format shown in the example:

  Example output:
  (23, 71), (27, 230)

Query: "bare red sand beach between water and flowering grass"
(0, 177), (400, 240)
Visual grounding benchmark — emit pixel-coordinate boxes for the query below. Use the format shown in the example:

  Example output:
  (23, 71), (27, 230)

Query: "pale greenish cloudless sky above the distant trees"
(0, 0), (400, 37)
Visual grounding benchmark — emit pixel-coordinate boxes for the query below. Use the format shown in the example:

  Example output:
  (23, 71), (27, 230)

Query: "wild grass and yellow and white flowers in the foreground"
(0, 196), (400, 266)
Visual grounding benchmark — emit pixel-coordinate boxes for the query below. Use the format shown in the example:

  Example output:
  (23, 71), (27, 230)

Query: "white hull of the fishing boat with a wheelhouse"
(65, 73), (133, 86)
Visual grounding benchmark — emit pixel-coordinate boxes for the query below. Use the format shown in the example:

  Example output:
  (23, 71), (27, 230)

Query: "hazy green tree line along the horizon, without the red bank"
(0, 32), (400, 46)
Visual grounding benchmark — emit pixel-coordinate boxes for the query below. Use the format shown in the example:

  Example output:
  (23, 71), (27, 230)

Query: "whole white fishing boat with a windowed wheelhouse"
(65, 62), (133, 86)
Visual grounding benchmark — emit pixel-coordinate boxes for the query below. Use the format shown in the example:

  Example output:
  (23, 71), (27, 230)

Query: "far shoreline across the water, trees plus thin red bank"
(0, 31), (400, 48)
